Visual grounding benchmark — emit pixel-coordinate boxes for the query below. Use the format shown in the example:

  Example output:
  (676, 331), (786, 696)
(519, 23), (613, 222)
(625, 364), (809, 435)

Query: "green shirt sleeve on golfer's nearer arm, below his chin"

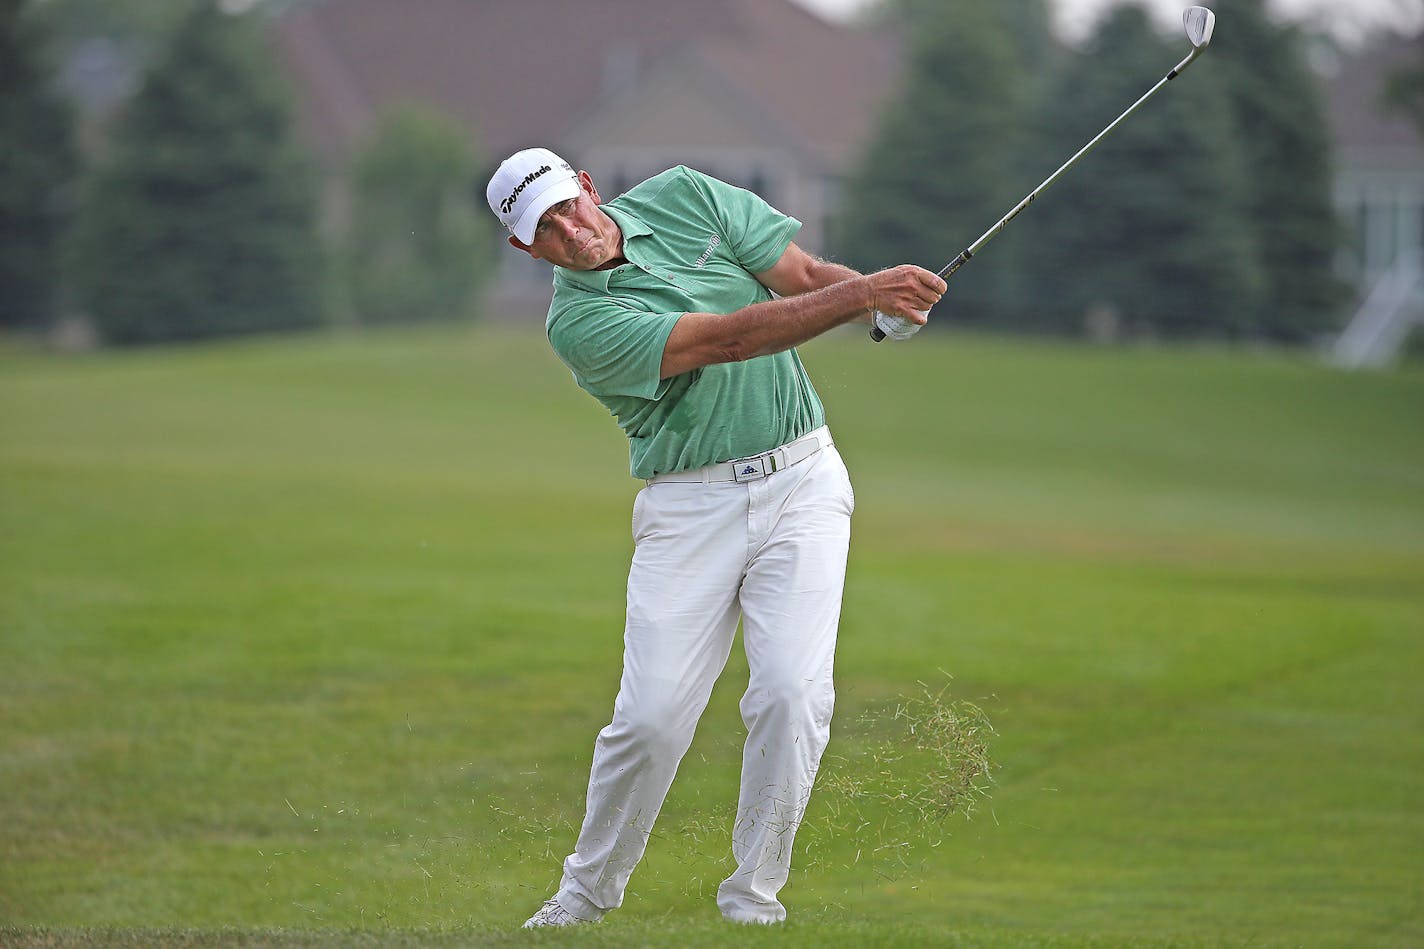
(548, 299), (682, 400)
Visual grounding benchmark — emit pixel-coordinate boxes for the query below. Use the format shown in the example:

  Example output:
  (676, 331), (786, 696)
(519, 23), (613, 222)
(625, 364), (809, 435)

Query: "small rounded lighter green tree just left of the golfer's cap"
(346, 107), (494, 323)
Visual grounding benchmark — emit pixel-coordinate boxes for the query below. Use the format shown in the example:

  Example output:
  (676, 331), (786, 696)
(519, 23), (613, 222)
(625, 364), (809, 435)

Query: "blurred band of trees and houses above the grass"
(8, 0), (1424, 366)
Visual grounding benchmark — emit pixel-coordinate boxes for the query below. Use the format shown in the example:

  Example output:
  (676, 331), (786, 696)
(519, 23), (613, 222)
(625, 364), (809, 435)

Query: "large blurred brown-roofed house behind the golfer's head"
(273, 0), (899, 316)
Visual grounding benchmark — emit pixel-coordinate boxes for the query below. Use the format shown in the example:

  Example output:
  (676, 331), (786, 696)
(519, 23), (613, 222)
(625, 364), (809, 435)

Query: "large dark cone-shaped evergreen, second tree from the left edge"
(75, 3), (322, 343)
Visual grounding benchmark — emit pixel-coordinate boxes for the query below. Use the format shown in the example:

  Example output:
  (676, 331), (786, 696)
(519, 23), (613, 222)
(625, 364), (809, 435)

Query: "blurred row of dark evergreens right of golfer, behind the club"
(837, 0), (1347, 342)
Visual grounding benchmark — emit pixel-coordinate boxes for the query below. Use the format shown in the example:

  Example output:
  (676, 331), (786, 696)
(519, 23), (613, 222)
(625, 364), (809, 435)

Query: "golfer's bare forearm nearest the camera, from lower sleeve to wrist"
(662, 268), (874, 379)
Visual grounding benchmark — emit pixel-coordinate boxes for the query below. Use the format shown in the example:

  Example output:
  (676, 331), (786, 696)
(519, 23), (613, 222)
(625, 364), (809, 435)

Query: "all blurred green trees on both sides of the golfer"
(0, 0), (1418, 343)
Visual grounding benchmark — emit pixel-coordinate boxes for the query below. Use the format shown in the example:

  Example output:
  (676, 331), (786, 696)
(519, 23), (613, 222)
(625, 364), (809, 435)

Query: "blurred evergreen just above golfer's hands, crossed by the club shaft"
(833, 0), (1047, 319)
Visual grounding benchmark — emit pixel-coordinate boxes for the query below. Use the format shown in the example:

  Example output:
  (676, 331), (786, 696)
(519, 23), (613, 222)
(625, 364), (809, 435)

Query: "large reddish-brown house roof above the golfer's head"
(273, 0), (897, 165)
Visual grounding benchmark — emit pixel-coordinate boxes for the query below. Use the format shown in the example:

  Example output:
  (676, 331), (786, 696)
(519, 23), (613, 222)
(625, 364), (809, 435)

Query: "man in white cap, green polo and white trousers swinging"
(487, 148), (946, 926)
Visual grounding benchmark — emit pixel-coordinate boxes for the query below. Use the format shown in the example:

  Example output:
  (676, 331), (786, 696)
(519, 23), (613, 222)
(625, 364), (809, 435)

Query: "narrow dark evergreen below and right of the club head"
(1209, 0), (1346, 341)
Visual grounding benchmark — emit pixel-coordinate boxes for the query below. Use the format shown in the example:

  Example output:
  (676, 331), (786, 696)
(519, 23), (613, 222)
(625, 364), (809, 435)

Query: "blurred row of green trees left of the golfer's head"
(0, 0), (494, 345)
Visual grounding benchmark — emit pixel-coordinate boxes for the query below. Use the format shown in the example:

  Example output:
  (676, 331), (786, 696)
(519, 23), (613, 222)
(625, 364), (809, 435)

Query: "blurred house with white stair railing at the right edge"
(1327, 34), (1424, 368)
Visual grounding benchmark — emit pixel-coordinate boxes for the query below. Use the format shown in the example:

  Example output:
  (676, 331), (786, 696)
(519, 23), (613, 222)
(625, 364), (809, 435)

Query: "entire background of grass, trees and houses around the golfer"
(0, 0), (1424, 929)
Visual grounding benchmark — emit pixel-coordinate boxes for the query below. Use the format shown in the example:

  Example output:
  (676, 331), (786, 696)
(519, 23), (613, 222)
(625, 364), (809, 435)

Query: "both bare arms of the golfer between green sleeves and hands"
(662, 244), (874, 379)
